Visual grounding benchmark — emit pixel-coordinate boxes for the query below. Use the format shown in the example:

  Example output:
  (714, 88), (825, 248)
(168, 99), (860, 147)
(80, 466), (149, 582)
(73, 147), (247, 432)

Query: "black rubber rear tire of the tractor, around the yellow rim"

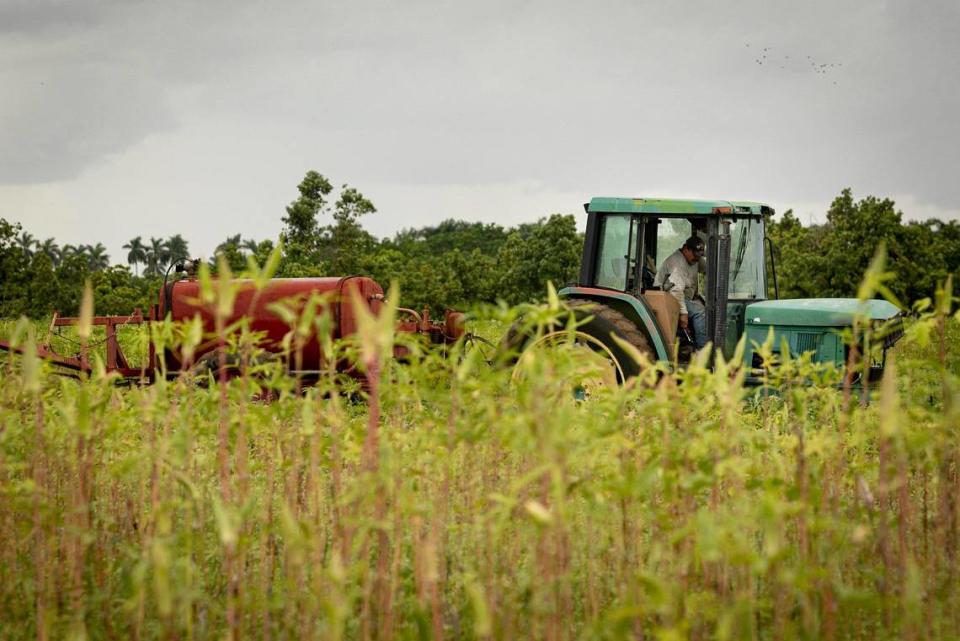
(504, 298), (657, 383)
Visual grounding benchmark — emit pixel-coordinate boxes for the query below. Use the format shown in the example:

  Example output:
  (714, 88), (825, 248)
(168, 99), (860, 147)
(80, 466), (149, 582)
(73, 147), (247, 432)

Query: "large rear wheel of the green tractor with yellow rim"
(504, 298), (657, 383)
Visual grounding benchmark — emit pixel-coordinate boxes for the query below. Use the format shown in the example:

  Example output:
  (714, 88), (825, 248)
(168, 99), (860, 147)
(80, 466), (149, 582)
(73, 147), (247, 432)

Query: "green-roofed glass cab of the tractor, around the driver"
(564, 198), (773, 361)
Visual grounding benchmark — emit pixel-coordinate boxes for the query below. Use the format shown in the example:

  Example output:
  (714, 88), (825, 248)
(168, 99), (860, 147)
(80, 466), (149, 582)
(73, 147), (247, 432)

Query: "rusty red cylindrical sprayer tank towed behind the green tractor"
(157, 276), (383, 371)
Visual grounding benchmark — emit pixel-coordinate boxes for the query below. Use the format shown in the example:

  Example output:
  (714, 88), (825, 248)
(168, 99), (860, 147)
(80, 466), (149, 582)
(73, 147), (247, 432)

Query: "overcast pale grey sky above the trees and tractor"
(0, 0), (960, 262)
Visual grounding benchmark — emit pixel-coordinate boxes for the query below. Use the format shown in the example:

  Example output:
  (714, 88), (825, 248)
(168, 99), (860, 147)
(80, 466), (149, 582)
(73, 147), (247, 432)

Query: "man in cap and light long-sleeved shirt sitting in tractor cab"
(653, 234), (708, 350)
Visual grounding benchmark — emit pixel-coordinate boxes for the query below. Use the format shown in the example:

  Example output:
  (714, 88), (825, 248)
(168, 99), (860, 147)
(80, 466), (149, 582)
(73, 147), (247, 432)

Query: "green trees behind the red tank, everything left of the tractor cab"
(0, 171), (583, 318)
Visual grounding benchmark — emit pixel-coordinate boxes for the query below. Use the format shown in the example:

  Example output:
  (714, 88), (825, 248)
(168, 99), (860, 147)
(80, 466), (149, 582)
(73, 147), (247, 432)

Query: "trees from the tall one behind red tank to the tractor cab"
(274, 172), (582, 313)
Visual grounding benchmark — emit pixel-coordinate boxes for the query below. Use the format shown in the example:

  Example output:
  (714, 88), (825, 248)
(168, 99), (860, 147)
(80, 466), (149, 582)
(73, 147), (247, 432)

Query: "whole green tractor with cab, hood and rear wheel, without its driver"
(508, 198), (902, 384)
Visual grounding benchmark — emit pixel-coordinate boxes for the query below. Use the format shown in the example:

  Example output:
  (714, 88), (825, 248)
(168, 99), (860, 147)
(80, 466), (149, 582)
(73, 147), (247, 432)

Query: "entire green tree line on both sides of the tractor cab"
(0, 171), (960, 318)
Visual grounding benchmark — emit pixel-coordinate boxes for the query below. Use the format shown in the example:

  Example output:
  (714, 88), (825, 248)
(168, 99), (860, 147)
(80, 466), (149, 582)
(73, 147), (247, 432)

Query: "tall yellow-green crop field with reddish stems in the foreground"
(0, 284), (960, 641)
